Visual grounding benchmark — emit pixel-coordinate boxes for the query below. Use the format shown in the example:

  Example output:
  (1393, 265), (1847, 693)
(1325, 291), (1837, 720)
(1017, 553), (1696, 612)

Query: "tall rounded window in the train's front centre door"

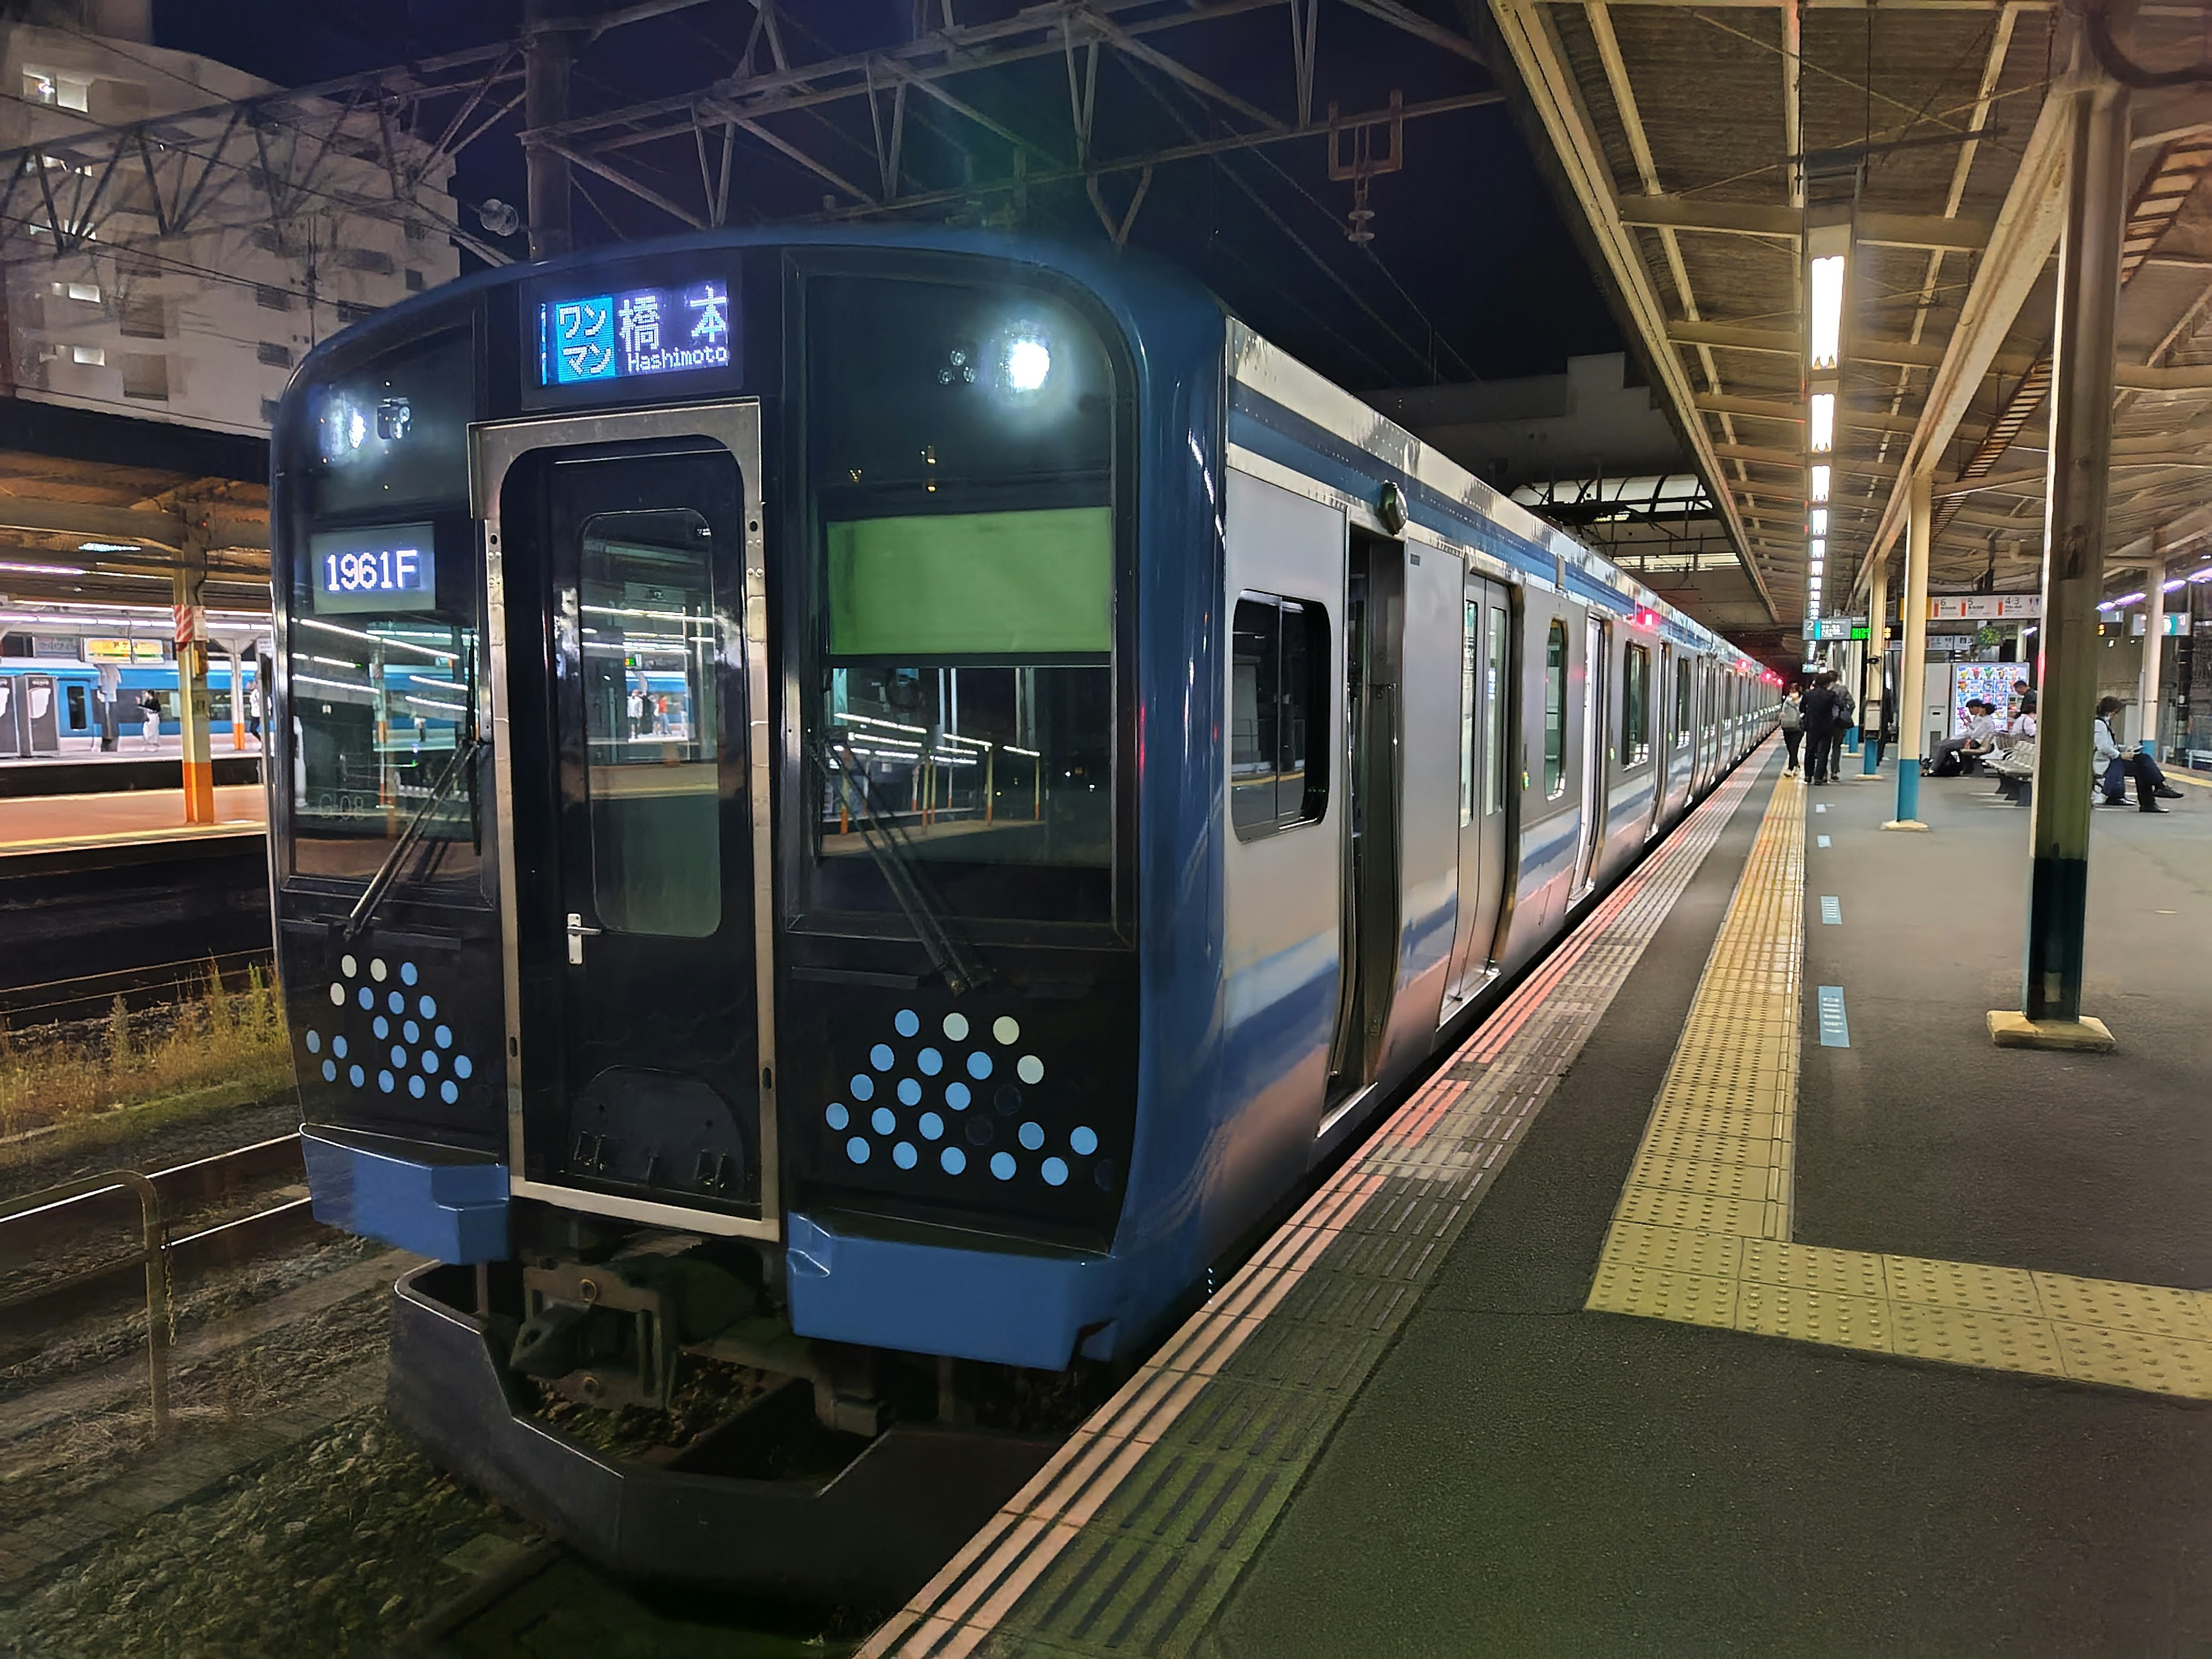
(577, 506), (721, 938)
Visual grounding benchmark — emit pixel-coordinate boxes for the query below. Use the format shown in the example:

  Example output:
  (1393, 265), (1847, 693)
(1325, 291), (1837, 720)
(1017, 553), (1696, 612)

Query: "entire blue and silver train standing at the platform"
(268, 230), (1774, 1590)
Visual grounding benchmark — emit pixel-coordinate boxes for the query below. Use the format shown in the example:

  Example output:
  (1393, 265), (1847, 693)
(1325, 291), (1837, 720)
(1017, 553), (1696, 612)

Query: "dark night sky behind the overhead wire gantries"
(155, 0), (1622, 389)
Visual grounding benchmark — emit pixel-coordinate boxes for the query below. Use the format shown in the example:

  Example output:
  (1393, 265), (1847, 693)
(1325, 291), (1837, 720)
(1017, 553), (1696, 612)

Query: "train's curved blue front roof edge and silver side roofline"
(285, 226), (1756, 668)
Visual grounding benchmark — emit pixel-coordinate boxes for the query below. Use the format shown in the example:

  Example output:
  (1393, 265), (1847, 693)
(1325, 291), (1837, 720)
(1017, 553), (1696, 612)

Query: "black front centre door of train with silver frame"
(476, 403), (779, 1237)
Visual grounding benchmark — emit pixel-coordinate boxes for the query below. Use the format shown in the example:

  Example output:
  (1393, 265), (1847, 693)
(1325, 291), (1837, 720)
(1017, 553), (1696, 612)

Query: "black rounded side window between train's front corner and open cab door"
(1230, 593), (1327, 840)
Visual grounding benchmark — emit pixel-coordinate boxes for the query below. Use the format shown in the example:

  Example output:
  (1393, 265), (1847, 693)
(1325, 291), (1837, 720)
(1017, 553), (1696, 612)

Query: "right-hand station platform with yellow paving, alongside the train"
(863, 745), (2212, 1659)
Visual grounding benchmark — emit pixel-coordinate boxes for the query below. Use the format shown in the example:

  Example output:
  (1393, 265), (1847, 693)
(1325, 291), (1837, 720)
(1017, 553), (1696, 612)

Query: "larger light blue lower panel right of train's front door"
(785, 1212), (1124, 1372)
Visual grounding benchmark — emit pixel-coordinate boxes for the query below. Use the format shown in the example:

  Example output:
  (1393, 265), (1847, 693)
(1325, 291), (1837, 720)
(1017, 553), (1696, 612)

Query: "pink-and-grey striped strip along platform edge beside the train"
(861, 756), (1772, 1659)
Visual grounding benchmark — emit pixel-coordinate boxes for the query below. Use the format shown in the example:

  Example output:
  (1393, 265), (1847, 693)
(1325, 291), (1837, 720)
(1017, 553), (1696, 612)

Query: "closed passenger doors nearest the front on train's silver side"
(1445, 575), (1520, 1017)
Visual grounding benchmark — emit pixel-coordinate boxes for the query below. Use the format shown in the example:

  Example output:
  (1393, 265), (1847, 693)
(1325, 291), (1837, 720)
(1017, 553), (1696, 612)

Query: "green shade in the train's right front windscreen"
(830, 506), (1113, 659)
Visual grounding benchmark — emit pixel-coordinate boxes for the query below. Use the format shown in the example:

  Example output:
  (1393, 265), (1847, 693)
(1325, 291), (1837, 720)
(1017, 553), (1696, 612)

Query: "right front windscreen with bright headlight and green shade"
(803, 272), (1124, 922)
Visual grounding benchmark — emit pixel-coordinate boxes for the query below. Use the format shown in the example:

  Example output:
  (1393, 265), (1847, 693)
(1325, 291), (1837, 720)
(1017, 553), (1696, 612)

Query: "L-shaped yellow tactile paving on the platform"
(1586, 779), (2212, 1400)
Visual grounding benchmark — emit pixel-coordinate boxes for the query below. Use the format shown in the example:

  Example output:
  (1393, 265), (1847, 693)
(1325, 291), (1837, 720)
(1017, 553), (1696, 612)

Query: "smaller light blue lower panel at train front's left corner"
(298, 1128), (506, 1263)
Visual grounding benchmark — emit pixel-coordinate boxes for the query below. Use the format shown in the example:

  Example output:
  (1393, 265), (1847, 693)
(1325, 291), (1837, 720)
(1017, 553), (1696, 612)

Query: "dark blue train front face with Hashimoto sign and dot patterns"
(270, 239), (1219, 1584)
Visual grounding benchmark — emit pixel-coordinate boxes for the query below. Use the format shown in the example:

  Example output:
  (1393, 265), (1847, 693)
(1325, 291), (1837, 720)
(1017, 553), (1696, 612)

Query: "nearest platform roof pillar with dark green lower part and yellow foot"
(1988, 73), (2123, 1048)
